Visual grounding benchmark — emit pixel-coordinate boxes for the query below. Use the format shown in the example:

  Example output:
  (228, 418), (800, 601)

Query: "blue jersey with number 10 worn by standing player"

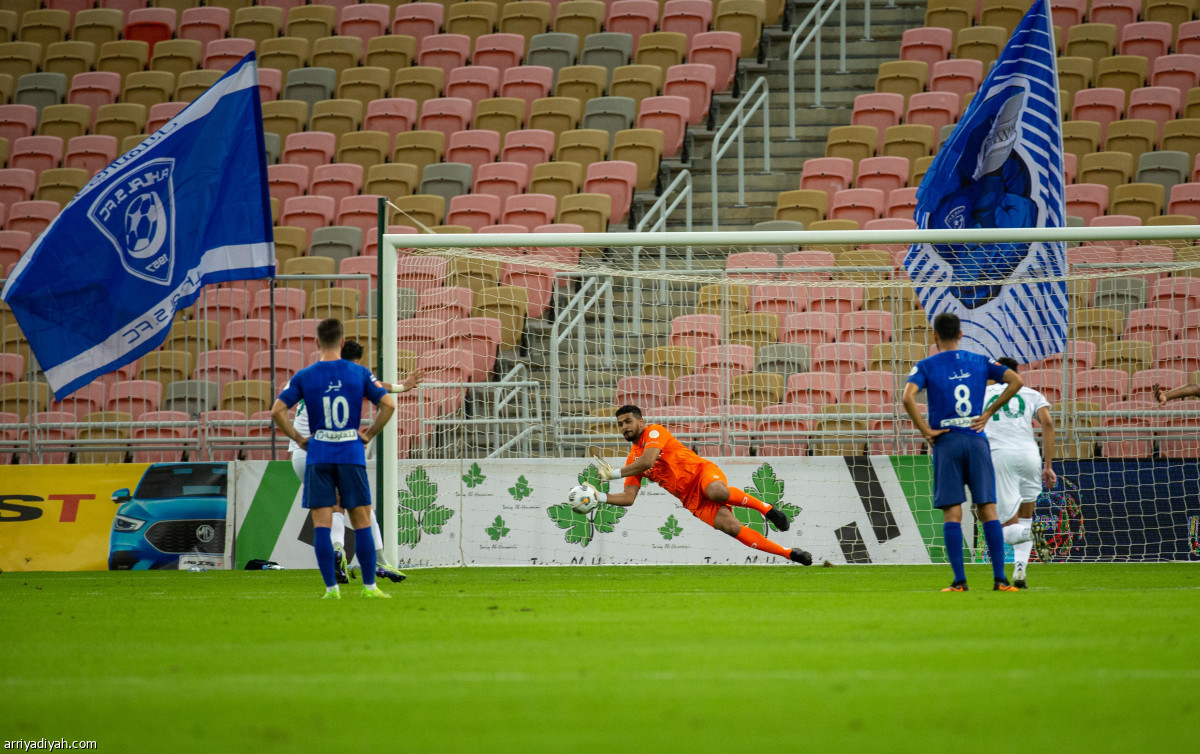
(280, 359), (388, 466)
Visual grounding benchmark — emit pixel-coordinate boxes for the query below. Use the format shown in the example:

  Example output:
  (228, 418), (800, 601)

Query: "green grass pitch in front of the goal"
(0, 564), (1200, 753)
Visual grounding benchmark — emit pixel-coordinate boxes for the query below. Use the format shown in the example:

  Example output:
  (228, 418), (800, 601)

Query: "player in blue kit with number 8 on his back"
(904, 312), (1022, 592)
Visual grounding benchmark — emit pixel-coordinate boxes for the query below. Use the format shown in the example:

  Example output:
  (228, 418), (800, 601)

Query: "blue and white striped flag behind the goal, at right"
(905, 0), (1067, 363)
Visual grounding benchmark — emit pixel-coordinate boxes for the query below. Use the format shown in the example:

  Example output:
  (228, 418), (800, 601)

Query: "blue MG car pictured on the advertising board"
(108, 463), (229, 570)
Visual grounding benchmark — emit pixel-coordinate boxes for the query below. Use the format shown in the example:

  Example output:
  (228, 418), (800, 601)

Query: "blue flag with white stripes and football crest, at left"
(0, 53), (275, 400)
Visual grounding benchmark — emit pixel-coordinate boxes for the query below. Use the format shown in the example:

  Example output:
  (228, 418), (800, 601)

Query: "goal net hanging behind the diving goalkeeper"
(370, 226), (1200, 564)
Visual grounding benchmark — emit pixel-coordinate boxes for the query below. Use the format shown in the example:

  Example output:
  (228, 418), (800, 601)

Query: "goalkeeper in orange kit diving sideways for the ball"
(585, 406), (812, 566)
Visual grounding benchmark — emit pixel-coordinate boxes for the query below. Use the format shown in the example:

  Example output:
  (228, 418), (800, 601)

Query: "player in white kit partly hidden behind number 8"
(984, 357), (1056, 590)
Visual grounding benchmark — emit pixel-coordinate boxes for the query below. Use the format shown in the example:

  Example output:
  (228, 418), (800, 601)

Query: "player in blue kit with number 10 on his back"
(271, 319), (396, 599)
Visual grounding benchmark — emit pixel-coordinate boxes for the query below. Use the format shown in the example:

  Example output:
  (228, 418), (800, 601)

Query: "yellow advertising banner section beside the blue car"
(0, 463), (149, 572)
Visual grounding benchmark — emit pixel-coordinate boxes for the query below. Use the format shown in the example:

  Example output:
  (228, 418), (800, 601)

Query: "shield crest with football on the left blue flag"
(88, 157), (175, 286)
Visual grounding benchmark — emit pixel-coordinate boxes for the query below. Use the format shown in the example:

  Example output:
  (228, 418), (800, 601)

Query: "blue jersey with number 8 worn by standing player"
(908, 351), (1008, 435)
